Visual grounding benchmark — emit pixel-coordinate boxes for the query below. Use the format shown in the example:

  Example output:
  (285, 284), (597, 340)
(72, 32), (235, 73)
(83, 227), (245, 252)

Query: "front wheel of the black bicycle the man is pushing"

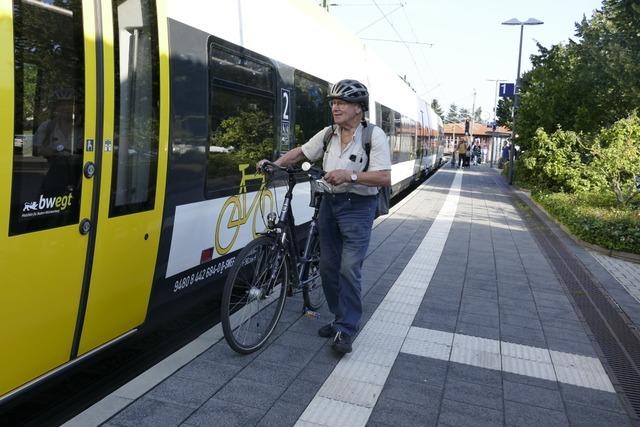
(222, 236), (289, 354)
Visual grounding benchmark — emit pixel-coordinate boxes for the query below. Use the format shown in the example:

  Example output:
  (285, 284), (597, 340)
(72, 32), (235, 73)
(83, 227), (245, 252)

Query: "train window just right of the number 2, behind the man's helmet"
(293, 71), (330, 144)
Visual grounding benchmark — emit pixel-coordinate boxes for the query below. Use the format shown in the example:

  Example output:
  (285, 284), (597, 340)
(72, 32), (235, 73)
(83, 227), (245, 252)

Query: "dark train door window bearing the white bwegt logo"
(9, 0), (84, 235)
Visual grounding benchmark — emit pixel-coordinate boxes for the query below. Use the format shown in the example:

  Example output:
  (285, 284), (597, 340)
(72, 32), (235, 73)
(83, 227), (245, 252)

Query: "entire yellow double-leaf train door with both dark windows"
(0, 0), (168, 399)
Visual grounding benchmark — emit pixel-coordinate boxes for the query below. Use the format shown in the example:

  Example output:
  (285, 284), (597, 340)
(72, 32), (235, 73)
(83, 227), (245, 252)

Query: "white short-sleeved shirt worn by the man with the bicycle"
(301, 124), (391, 196)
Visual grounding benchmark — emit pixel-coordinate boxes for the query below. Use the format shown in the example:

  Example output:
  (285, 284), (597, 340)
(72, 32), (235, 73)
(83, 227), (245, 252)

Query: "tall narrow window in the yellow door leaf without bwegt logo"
(109, 0), (159, 216)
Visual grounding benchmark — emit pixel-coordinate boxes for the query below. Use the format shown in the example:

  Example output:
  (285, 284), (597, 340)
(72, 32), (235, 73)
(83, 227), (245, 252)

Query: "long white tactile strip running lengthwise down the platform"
(296, 171), (462, 427)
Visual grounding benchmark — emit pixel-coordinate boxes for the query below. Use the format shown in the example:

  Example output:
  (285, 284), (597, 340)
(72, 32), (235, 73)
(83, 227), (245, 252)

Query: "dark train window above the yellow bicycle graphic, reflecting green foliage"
(206, 38), (275, 198)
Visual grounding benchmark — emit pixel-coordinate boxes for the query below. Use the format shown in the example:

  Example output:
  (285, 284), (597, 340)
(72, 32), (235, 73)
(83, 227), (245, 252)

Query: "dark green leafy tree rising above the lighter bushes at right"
(516, 0), (640, 150)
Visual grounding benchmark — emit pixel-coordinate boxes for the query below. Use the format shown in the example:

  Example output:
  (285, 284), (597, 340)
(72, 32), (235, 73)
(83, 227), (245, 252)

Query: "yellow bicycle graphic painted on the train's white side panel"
(214, 164), (273, 255)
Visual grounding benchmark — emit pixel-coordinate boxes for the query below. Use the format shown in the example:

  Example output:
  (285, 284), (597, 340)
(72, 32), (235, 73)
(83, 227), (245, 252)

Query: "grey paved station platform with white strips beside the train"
(66, 166), (640, 427)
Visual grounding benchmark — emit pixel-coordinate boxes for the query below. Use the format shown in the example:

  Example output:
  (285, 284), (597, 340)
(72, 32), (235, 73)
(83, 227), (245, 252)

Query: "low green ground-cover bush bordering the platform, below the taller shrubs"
(533, 192), (640, 254)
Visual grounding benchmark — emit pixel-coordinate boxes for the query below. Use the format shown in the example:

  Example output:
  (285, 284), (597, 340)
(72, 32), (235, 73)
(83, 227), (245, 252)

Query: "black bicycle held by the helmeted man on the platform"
(221, 162), (324, 354)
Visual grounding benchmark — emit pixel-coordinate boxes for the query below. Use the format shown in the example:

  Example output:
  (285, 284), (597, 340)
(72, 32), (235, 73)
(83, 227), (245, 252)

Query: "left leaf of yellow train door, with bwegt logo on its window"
(0, 0), (96, 396)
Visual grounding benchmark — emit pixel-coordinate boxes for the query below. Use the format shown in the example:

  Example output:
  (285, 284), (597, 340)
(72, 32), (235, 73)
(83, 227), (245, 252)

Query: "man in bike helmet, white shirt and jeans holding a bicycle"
(258, 80), (391, 354)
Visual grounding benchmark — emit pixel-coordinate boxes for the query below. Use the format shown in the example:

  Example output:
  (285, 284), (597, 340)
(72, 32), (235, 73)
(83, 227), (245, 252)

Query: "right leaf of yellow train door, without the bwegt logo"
(77, 0), (168, 354)
